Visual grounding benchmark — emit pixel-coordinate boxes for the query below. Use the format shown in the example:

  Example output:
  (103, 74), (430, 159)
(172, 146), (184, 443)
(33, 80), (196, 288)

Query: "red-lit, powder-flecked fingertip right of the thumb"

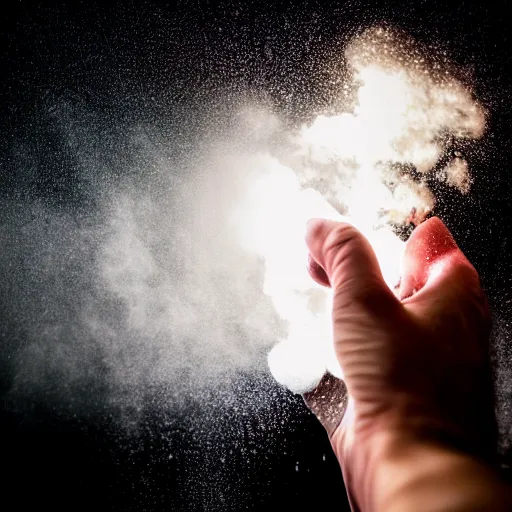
(399, 217), (475, 300)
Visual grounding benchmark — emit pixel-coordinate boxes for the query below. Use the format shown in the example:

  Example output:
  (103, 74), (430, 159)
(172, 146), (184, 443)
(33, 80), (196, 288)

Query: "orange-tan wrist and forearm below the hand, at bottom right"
(342, 436), (512, 512)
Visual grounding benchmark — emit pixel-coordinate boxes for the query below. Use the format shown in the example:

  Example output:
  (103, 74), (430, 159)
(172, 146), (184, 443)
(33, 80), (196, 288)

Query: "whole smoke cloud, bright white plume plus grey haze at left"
(0, 30), (485, 420)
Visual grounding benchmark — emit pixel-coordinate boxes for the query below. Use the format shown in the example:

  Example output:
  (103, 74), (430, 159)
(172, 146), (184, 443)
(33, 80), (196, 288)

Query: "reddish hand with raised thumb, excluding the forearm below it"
(306, 218), (496, 506)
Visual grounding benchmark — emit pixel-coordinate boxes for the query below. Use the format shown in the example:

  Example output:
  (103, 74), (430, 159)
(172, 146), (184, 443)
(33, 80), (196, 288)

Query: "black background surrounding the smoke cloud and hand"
(0, 0), (512, 511)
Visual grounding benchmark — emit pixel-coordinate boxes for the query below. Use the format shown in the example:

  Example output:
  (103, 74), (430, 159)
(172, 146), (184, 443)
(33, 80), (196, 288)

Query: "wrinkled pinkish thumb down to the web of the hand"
(306, 219), (396, 302)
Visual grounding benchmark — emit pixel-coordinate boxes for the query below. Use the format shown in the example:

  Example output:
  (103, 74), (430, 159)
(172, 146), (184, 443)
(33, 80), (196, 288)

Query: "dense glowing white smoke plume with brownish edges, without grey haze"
(237, 29), (485, 392)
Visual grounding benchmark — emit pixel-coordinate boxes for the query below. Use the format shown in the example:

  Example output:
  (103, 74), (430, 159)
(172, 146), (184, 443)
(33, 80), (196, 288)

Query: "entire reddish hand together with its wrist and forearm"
(306, 218), (512, 512)
